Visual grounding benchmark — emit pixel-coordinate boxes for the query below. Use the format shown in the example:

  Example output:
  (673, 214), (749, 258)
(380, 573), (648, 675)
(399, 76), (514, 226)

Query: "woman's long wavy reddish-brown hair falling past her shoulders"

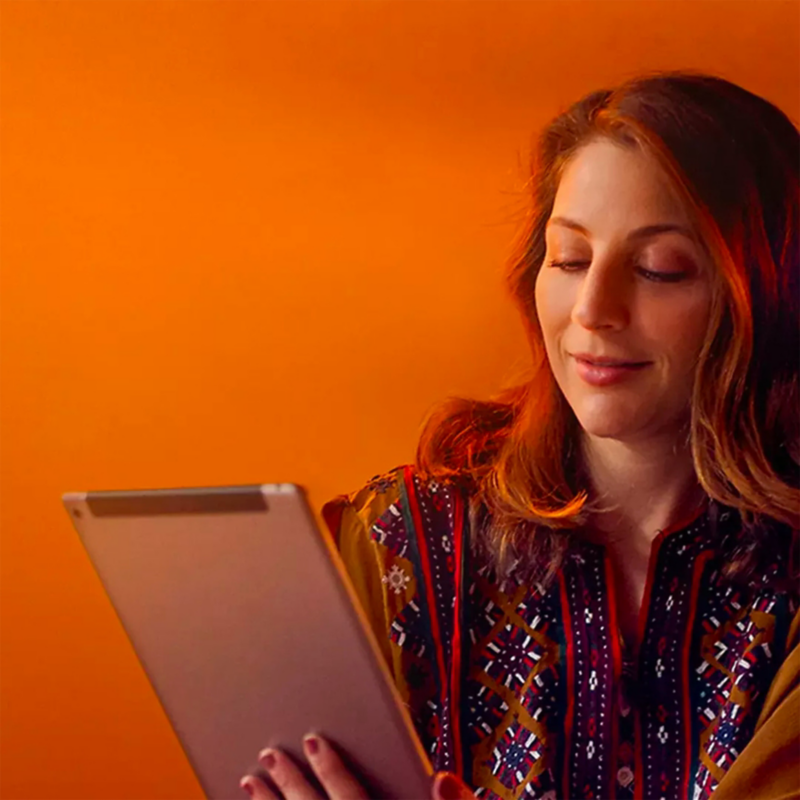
(417, 72), (800, 583)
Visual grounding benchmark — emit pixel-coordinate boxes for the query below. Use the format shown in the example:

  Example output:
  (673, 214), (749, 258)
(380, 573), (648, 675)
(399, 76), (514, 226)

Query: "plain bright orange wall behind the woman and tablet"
(0, 0), (800, 800)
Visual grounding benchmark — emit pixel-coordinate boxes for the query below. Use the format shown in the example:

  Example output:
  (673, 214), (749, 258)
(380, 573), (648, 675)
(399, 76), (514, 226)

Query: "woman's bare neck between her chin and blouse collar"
(581, 428), (706, 544)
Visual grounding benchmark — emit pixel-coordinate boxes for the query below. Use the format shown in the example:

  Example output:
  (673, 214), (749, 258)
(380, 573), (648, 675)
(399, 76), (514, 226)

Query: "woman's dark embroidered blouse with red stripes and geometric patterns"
(323, 467), (798, 800)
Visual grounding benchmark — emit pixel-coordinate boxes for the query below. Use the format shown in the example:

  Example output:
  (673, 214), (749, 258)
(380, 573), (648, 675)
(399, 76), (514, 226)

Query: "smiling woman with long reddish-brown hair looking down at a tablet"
(243, 73), (800, 800)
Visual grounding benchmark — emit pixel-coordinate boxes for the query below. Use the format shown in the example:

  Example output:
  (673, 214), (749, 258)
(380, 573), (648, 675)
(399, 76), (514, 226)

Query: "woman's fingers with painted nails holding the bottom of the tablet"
(239, 734), (475, 800)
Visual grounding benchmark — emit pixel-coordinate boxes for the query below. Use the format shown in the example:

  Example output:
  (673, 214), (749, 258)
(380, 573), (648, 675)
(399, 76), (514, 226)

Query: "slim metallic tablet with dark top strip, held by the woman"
(62, 484), (433, 800)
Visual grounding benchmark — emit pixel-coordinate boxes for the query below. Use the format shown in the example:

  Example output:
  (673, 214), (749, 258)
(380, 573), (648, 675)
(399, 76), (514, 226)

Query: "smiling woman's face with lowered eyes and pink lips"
(536, 140), (712, 442)
